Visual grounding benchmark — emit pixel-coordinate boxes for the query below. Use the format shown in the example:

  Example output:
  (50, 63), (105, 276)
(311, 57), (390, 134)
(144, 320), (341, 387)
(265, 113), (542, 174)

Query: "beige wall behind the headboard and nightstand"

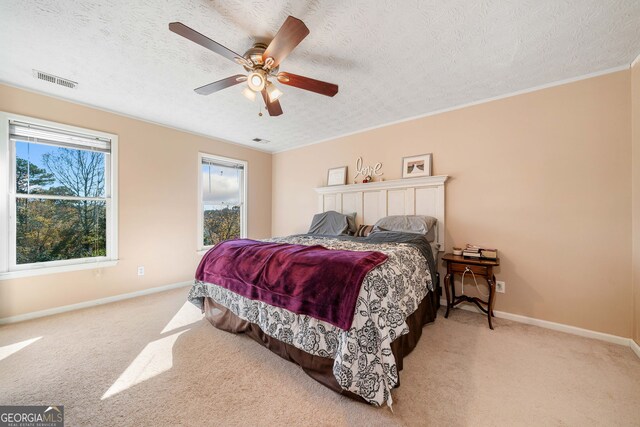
(272, 71), (633, 337)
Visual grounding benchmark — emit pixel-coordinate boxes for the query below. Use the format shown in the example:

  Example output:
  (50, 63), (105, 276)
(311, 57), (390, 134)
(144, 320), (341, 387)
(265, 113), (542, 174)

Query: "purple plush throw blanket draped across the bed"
(196, 239), (387, 330)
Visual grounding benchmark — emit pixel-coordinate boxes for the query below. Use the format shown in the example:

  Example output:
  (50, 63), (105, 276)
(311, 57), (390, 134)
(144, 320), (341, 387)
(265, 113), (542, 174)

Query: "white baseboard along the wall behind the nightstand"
(440, 298), (640, 358)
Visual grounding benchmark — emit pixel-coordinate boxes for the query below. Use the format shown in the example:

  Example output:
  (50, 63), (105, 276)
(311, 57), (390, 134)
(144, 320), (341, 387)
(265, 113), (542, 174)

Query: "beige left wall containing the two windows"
(0, 85), (271, 318)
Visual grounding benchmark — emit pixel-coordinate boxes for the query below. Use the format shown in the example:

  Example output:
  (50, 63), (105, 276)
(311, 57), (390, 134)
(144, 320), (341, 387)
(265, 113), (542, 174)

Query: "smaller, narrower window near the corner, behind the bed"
(198, 153), (247, 249)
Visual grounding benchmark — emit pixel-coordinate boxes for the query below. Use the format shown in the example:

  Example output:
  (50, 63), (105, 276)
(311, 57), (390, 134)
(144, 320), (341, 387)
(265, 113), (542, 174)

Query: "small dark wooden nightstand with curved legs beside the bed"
(442, 254), (500, 329)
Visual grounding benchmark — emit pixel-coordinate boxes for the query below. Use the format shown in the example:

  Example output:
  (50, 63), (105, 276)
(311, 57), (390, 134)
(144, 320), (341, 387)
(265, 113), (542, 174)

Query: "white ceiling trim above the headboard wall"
(273, 64), (628, 154)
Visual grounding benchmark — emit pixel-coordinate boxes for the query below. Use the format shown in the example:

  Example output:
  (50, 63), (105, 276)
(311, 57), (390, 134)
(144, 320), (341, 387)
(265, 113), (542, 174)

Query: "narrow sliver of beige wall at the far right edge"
(631, 61), (640, 344)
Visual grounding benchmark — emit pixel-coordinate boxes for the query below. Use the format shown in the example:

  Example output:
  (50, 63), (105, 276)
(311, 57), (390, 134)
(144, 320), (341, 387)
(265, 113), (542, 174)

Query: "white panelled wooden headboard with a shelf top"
(315, 175), (449, 251)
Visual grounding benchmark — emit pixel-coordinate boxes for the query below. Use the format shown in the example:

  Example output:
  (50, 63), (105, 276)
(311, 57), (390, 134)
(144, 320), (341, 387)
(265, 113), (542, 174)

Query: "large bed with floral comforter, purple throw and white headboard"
(188, 177), (446, 406)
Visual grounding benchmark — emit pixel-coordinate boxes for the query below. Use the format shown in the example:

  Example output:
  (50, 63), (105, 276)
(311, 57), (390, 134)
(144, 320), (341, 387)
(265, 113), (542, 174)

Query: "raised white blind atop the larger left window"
(9, 120), (111, 153)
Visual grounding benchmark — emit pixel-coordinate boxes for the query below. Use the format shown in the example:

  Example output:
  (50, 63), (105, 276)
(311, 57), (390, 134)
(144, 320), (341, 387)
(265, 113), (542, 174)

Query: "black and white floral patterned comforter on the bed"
(188, 235), (433, 406)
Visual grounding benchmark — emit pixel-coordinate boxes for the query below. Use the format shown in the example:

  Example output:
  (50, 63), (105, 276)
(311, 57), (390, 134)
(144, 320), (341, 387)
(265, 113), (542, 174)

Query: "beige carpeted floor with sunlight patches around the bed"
(0, 288), (640, 426)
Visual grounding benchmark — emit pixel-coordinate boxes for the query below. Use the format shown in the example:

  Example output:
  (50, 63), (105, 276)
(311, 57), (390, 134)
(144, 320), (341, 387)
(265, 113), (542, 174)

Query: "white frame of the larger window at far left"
(0, 111), (118, 280)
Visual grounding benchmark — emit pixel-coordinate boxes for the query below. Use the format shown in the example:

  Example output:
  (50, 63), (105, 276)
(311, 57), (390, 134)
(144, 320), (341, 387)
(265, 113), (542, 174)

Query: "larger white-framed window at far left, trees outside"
(0, 113), (117, 277)
